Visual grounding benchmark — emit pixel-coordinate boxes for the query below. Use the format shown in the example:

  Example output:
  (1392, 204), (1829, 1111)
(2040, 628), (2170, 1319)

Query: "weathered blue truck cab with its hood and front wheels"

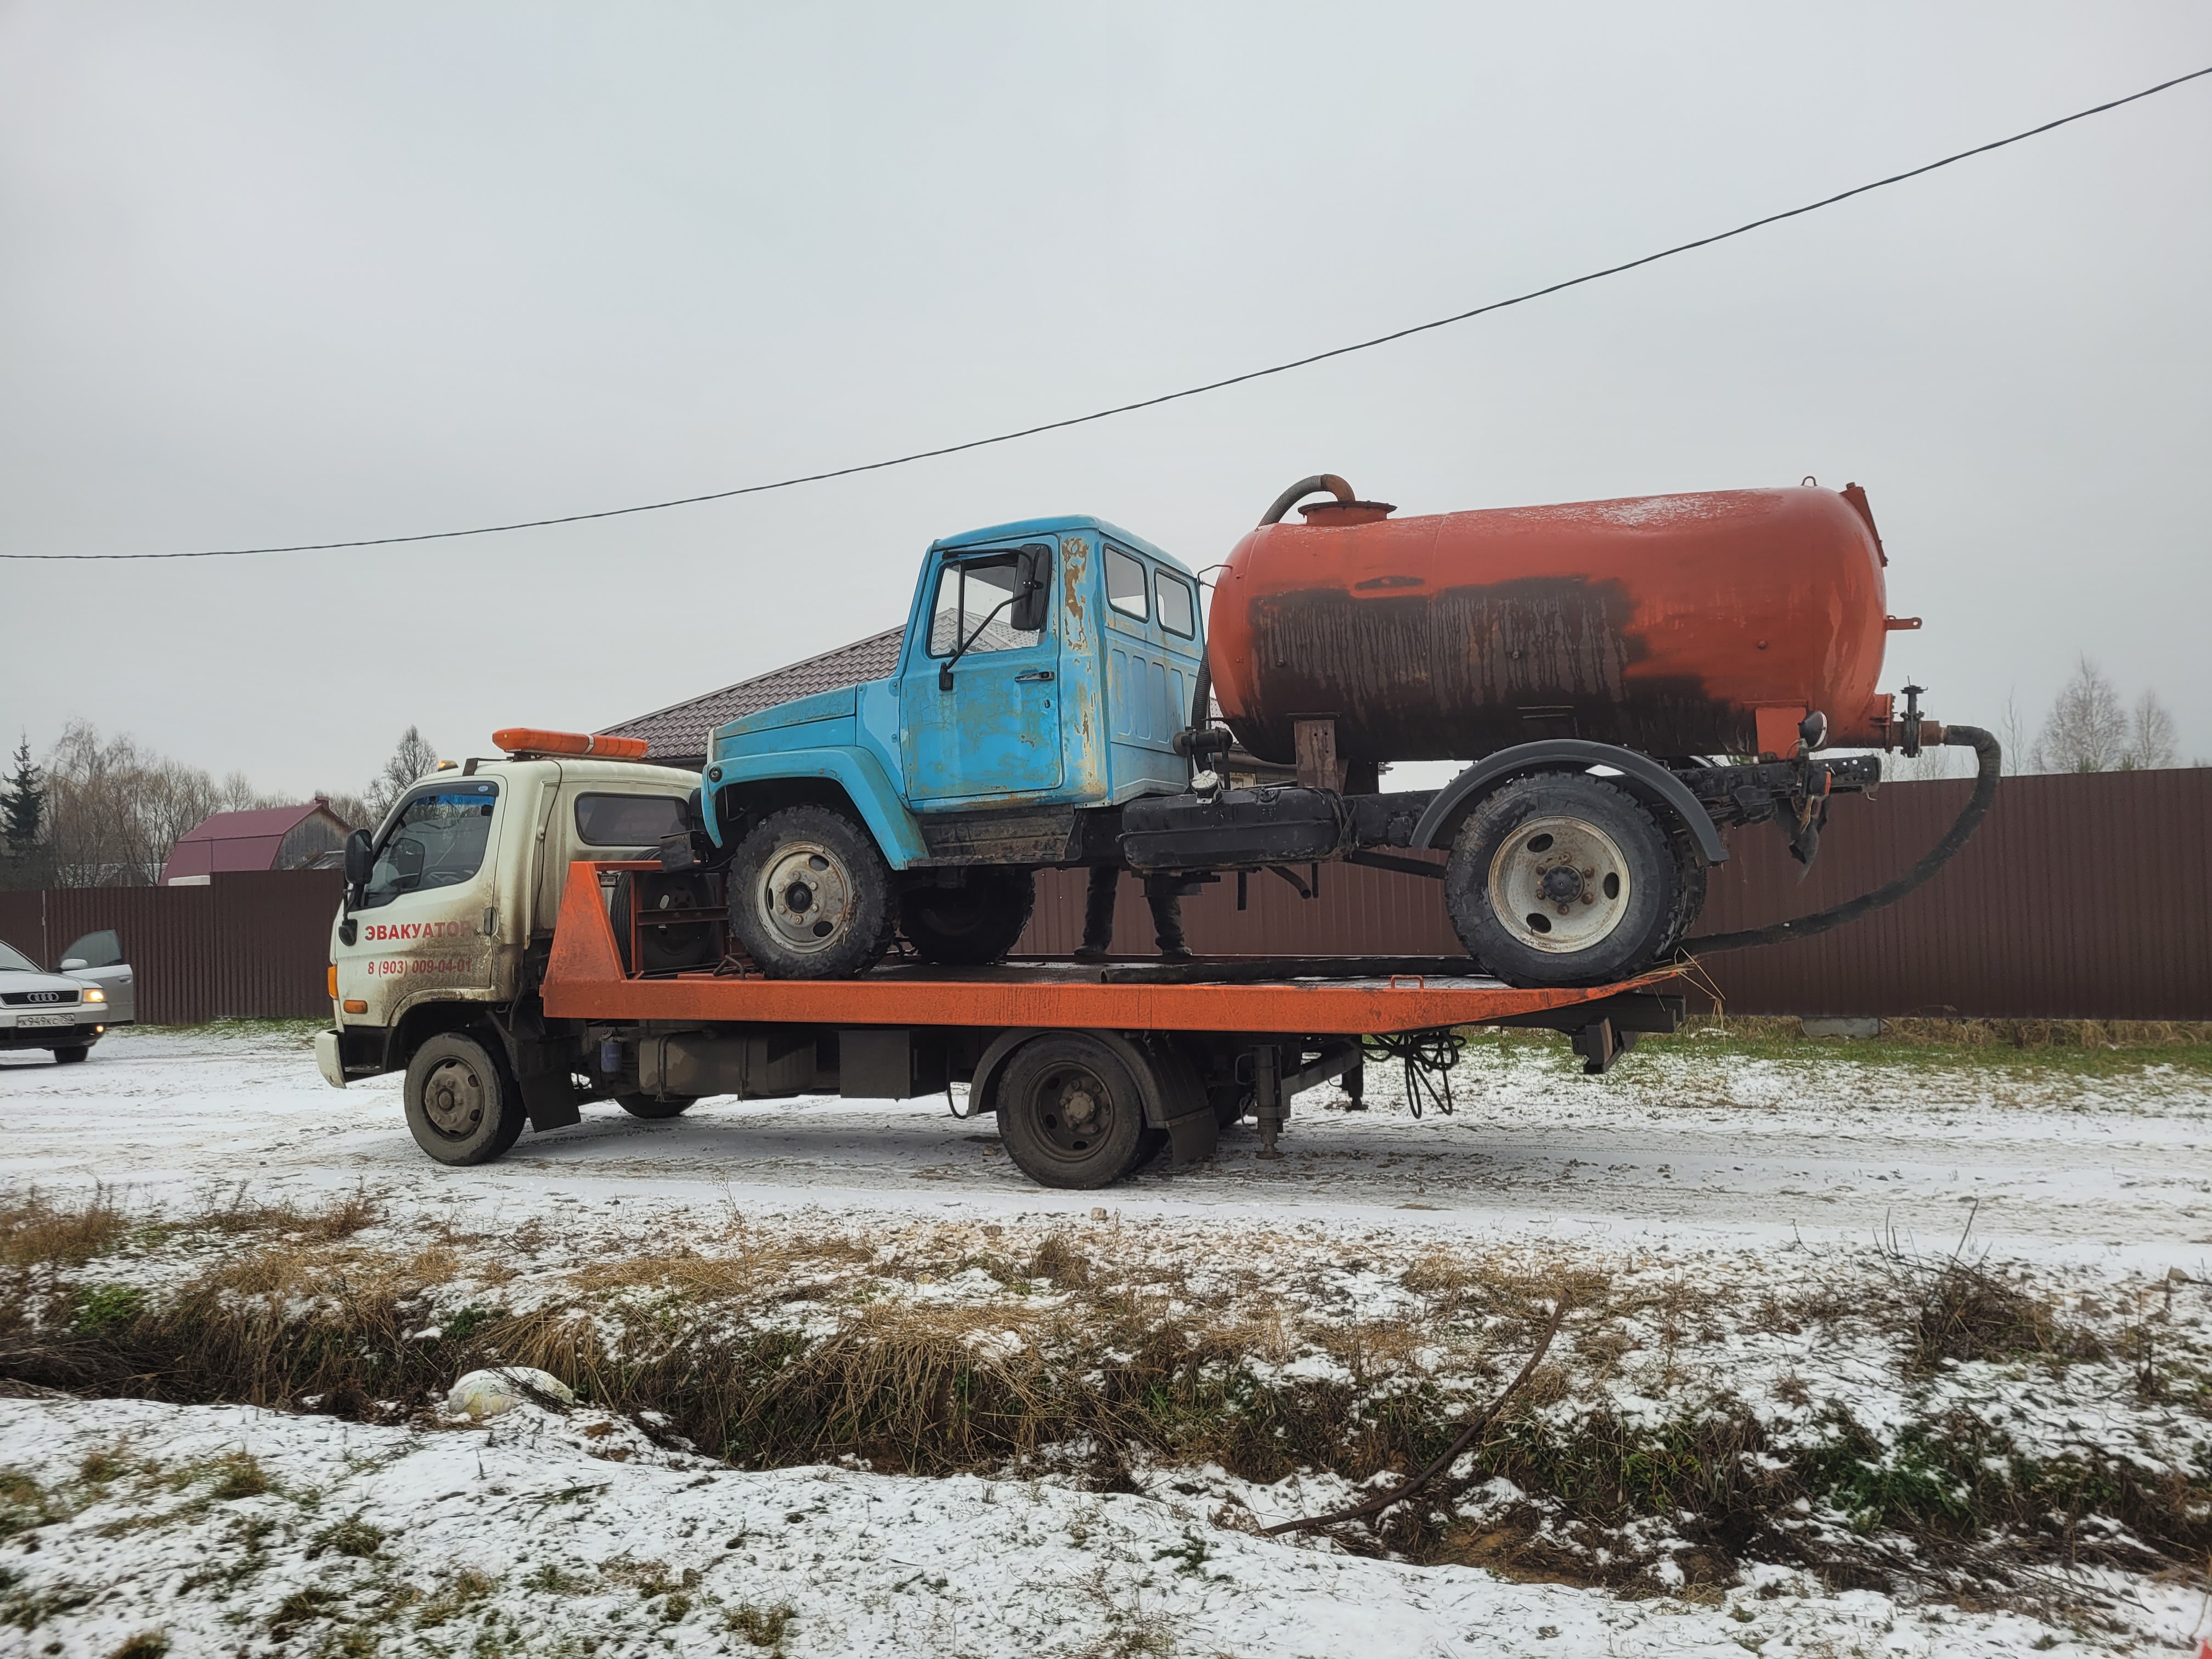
(699, 517), (1205, 978)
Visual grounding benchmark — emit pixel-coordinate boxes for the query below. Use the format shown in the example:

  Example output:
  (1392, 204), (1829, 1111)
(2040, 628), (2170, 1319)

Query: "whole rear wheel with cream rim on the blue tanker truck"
(1444, 772), (1688, 986)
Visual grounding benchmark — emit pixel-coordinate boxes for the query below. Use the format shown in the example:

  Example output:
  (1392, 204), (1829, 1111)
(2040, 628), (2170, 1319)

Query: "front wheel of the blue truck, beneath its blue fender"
(723, 805), (898, 980)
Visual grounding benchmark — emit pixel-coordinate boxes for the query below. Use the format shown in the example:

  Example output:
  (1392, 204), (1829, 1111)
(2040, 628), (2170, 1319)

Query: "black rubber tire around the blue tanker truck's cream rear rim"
(1444, 772), (1688, 986)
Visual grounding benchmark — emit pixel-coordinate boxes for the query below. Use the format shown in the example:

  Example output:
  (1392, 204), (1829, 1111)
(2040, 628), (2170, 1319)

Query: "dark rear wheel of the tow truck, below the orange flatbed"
(995, 1031), (1146, 1190)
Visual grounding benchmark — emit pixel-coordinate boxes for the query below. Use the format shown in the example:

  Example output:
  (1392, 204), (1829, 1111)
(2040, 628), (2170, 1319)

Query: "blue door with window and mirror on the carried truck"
(898, 546), (1064, 810)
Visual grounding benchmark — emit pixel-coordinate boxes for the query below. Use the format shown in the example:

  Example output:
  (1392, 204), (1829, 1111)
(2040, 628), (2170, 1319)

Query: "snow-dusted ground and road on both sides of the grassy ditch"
(0, 1029), (2212, 1659)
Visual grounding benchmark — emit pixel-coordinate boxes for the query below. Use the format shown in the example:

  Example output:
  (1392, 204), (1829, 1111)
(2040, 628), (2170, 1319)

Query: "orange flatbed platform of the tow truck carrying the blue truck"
(542, 862), (1672, 1037)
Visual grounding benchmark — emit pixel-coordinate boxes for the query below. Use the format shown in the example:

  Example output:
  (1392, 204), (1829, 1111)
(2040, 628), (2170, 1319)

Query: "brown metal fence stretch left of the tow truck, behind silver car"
(0, 870), (345, 1024)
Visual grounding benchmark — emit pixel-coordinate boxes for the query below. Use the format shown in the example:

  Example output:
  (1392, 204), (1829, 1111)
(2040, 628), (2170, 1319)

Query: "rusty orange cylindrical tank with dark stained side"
(1207, 484), (1889, 761)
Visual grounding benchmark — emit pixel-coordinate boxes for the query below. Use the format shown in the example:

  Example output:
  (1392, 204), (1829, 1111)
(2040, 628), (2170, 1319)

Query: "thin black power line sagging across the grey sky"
(0, 66), (2212, 560)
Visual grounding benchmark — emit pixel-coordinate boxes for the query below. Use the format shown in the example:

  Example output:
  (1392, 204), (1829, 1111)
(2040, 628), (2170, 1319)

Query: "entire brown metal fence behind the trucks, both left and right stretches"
(0, 768), (2212, 1024)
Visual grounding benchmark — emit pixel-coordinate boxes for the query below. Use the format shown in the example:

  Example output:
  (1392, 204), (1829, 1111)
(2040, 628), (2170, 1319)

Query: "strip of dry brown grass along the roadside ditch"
(0, 1203), (2212, 1601)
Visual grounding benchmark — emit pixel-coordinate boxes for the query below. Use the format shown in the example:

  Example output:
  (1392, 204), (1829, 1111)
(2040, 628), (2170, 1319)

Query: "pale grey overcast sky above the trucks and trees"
(0, 0), (2212, 792)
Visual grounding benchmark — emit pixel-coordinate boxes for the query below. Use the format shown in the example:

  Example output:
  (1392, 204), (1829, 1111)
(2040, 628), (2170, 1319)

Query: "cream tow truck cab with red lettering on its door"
(317, 757), (697, 1088)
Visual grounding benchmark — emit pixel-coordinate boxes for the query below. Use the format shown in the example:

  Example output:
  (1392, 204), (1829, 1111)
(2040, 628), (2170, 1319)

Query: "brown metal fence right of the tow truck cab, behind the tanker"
(1020, 768), (2212, 1020)
